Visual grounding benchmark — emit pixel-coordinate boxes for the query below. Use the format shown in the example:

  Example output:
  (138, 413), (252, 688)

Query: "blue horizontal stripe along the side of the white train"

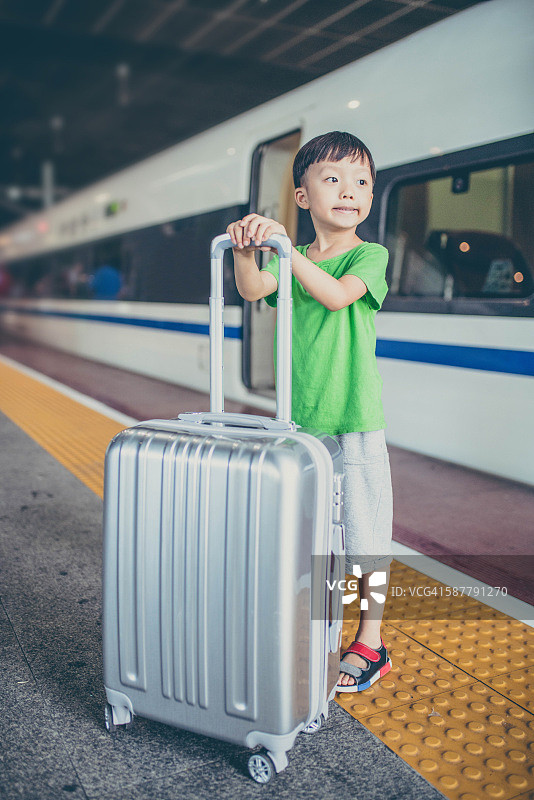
(0, 304), (534, 376)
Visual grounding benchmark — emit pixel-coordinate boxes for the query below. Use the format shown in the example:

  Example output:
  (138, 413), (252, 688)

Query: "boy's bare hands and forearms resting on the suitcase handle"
(234, 214), (367, 311)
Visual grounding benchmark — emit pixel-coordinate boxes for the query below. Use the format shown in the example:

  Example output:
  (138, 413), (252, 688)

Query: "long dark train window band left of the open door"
(2, 206), (246, 305)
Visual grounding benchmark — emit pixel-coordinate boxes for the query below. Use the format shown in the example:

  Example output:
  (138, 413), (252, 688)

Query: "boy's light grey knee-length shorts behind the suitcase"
(335, 430), (393, 574)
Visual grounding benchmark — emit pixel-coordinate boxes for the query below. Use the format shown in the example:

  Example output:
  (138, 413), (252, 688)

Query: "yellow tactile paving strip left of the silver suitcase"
(0, 361), (124, 497)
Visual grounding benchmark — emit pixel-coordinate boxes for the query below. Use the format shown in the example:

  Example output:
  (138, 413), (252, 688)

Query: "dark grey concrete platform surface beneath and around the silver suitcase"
(0, 415), (443, 800)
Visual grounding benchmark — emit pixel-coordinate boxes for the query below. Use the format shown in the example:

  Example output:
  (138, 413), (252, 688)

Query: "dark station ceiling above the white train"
(0, 0), (486, 225)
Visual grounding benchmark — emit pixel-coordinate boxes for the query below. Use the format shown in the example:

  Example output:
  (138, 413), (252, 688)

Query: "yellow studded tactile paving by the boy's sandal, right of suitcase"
(337, 561), (534, 800)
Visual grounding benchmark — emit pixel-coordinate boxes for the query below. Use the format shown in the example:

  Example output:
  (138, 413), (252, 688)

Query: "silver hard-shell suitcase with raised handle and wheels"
(103, 235), (344, 783)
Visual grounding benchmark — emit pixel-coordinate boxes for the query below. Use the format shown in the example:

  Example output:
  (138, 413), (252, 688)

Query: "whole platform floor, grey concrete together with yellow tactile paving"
(0, 340), (534, 800)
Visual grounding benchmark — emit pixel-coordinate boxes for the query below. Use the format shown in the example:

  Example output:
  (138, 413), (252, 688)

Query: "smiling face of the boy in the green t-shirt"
(295, 157), (373, 230)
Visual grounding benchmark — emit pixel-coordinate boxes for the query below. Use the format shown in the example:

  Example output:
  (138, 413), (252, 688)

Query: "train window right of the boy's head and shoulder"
(386, 162), (534, 300)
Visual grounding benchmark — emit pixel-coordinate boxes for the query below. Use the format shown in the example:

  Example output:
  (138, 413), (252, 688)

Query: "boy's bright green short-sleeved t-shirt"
(265, 242), (388, 436)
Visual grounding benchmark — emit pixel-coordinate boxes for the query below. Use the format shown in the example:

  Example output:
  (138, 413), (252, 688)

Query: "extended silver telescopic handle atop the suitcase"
(210, 233), (292, 426)
